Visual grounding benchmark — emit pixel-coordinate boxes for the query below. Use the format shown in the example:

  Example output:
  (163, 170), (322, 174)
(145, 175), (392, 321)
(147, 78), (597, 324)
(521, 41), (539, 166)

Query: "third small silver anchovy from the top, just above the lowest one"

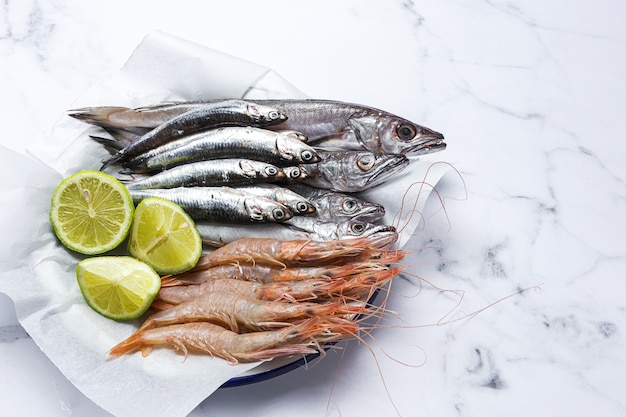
(123, 158), (284, 190)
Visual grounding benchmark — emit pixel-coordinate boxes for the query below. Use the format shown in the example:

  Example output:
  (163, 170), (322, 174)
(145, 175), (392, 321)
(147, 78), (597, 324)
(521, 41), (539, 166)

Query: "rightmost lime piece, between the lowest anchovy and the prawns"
(128, 197), (202, 274)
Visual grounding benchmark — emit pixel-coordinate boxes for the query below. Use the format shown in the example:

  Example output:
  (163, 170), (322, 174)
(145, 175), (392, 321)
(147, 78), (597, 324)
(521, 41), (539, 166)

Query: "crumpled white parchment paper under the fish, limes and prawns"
(0, 32), (446, 417)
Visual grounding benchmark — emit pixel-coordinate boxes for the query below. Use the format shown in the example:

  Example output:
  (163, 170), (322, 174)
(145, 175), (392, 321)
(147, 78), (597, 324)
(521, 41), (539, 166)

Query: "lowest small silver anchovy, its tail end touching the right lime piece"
(129, 187), (293, 223)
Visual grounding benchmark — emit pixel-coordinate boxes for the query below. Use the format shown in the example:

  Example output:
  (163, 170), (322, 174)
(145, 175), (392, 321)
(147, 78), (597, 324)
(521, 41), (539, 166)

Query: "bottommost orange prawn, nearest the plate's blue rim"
(109, 317), (356, 365)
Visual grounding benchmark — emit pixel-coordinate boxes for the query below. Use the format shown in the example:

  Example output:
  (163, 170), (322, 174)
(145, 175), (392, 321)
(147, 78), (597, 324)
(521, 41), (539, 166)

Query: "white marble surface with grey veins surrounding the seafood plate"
(0, 0), (626, 417)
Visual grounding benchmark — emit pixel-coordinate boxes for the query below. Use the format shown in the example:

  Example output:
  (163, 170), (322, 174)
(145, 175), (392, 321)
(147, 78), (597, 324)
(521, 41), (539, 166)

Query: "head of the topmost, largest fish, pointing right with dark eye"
(348, 112), (446, 155)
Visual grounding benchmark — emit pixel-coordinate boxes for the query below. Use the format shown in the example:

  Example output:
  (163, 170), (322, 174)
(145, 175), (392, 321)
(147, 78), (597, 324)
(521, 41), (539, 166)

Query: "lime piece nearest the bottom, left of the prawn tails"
(76, 256), (161, 320)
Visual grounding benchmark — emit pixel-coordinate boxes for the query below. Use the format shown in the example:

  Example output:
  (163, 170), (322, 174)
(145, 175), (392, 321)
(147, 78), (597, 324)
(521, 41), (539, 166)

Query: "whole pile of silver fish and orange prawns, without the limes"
(69, 99), (446, 363)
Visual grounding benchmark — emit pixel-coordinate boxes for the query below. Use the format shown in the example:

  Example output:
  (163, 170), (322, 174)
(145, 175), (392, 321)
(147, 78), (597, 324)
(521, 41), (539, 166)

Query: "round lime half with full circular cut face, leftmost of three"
(50, 170), (134, 255)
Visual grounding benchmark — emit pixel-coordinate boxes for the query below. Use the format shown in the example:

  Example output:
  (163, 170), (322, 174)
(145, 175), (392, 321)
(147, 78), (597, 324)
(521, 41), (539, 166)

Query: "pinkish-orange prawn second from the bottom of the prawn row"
(140, 291), (364, 332)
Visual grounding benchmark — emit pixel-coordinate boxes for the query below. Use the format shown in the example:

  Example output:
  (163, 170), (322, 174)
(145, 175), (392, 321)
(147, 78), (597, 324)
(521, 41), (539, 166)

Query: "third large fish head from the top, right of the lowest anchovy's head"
(289, 183), (385, 223)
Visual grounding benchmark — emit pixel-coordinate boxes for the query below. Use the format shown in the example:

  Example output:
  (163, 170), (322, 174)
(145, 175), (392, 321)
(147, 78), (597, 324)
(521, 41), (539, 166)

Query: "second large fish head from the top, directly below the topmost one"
(334, 151), (409, 192)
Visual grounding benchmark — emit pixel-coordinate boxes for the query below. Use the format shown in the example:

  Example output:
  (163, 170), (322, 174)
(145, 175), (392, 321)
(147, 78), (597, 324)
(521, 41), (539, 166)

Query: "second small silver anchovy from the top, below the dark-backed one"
(122, 127), (320, 172)
